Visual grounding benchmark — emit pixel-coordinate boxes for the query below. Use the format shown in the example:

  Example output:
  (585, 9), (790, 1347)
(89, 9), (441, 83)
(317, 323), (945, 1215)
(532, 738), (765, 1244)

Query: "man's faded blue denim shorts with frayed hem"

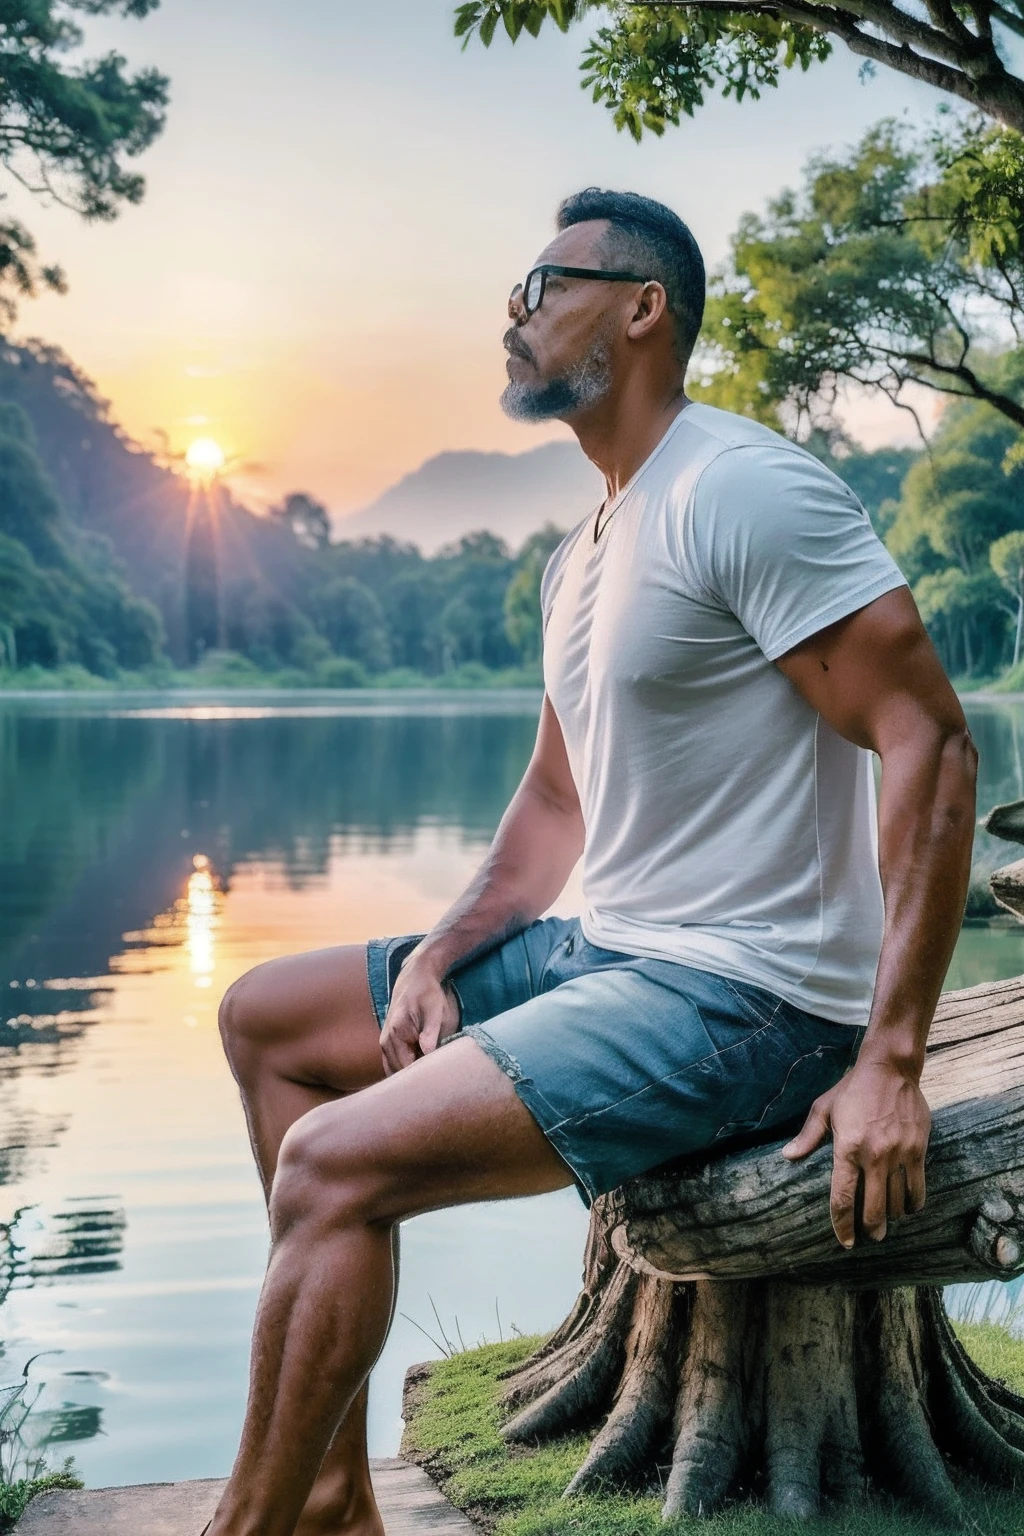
(367, 917), (866, 1204)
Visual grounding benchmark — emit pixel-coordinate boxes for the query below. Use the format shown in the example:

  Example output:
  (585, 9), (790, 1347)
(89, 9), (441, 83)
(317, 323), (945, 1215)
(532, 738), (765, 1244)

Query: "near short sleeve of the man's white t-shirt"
(685, 444), (907, 660)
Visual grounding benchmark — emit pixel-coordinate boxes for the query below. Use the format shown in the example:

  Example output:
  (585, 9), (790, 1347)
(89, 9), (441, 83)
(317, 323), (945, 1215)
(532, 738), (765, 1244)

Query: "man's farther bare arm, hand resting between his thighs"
(381, 696), (583, 1071)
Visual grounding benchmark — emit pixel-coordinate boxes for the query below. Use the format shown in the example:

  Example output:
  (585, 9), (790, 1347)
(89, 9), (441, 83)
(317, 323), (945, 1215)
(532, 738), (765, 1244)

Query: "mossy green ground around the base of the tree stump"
(402, 1322), (1024, 1536)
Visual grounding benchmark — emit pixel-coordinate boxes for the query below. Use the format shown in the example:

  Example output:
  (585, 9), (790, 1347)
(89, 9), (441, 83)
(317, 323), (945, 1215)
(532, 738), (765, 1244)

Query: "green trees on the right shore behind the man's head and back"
(694, 112), (1024, 687)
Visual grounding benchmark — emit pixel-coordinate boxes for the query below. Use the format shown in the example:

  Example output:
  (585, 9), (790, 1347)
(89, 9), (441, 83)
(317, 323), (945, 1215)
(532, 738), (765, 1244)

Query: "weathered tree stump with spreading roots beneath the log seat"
(504, 1247), (1024, 1528)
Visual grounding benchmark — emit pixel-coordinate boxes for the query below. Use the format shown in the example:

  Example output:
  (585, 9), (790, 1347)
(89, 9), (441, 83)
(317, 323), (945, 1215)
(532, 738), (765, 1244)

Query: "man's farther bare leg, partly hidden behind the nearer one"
(221, 945), (429, 1536)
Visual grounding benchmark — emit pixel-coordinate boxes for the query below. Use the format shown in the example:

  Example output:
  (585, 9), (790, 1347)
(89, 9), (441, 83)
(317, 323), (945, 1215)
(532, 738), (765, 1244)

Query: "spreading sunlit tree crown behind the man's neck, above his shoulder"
(697, 117), (1024, 427)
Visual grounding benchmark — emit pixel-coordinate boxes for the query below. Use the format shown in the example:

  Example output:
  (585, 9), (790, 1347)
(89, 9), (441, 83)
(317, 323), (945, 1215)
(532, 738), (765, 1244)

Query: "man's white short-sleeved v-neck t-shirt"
(540, 402), (906, 1025)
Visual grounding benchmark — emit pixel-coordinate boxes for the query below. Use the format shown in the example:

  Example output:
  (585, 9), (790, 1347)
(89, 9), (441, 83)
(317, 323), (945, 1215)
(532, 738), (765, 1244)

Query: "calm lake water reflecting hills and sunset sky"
(0, 696), (1024, 1485)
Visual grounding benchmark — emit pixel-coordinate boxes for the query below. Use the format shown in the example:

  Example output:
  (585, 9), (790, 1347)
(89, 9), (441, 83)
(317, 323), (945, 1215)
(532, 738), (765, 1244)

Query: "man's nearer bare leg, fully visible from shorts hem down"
(210, 1040), (571, 1536)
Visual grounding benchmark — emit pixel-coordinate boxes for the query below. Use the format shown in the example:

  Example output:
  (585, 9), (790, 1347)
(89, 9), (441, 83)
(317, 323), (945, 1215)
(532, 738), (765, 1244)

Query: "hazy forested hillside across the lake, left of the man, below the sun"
(0, 344), (560, 687)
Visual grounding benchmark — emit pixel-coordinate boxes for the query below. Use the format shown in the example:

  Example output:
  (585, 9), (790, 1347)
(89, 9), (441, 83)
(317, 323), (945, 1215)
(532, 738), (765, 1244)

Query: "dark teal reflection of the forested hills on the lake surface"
(0, 702), (536, 1183)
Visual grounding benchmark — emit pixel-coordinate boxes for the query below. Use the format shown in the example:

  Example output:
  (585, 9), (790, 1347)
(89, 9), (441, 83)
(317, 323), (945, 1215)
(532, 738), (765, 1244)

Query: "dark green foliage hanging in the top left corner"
(0, 0), (167, 319)
